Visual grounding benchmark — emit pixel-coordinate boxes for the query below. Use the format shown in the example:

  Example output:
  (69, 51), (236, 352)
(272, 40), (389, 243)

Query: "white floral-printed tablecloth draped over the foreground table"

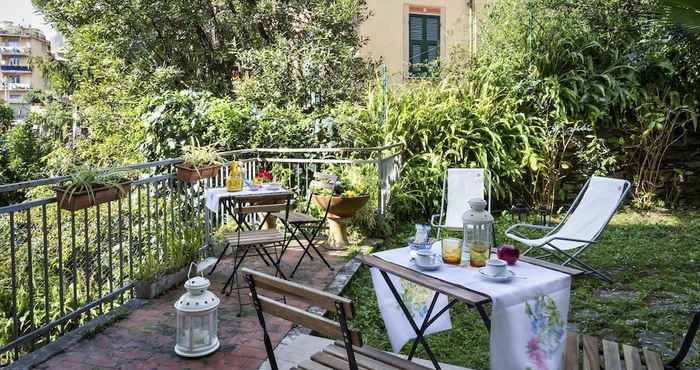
(372, 248), (571, 370)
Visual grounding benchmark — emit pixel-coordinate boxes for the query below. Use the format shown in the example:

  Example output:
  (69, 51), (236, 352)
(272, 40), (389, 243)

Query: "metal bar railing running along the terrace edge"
(0, 146), (400, 364)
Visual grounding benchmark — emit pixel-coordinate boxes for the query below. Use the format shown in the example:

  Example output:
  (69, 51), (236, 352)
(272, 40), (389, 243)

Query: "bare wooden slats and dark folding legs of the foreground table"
(359, 255), (583, 369)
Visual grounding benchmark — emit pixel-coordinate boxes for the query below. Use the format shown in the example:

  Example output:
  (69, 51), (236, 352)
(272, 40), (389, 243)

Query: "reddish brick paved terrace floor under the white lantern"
(36, 243), (348, 370)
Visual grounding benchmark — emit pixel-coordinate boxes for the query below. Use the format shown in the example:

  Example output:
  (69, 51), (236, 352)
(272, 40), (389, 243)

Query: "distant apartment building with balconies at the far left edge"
(0, 22), (51, 120)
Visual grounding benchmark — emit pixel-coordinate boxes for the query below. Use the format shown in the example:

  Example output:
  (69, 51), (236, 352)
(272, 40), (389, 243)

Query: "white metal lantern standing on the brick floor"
(175, 268), (220, 357)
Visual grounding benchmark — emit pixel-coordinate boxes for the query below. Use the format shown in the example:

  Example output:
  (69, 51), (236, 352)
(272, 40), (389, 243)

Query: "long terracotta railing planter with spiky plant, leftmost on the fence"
(54, 166), (131, 211)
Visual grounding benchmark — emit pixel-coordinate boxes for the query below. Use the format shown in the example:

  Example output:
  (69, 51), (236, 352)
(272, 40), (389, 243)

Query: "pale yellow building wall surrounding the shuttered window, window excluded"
(360, 0), (483, 79)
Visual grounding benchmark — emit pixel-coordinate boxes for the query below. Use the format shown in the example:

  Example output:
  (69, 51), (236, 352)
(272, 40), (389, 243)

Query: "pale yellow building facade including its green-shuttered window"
(360, 0), (485, 80)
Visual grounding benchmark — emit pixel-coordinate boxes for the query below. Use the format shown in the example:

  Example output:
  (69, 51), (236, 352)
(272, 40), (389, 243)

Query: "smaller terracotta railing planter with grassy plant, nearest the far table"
(175, 140), (225, 184)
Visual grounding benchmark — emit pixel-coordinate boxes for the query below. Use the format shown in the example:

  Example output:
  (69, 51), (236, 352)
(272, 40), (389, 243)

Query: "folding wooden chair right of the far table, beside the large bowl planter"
(272, 172), (338, 278)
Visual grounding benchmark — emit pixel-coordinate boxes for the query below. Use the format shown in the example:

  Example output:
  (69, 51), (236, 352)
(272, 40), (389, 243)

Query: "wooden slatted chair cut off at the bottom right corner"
(563, 311), (700, 370)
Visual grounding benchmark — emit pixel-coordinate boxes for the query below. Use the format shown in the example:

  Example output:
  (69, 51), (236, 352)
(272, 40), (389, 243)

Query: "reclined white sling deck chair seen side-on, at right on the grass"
(506, 176), (630, 282)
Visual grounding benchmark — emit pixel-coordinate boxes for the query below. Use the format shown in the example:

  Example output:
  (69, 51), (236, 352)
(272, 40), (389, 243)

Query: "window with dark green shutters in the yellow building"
(408, 14), (440, 77)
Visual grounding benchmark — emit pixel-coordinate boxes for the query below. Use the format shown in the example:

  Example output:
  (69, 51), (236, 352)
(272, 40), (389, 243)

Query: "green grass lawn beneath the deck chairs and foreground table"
(344, 210), (700, 369)
